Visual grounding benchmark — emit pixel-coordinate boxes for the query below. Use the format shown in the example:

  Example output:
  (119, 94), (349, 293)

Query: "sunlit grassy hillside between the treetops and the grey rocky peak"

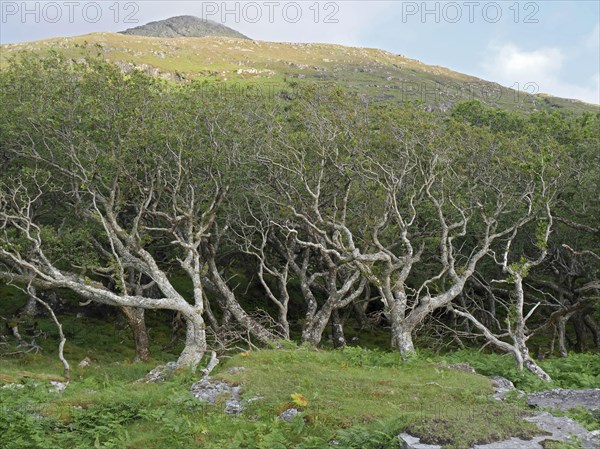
(0, 33), (598, 112)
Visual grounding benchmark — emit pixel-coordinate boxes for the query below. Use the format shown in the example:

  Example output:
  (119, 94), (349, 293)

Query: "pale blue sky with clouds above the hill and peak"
(0, 0), (600, 104)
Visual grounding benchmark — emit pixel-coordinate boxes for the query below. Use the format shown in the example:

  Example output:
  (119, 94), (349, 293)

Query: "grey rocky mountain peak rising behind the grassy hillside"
(120, 16), (250, 39)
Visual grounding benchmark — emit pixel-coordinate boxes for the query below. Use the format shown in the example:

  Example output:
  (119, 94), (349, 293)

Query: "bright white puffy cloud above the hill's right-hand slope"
(482, 43), (600, 104)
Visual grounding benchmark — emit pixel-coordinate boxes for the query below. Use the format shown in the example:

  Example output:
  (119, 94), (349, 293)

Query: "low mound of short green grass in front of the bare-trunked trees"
(212, 348), (531, 448)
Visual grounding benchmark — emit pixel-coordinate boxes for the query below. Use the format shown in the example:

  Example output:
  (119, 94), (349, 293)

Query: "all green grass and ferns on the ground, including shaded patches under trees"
(0, 285), (600, 449)
